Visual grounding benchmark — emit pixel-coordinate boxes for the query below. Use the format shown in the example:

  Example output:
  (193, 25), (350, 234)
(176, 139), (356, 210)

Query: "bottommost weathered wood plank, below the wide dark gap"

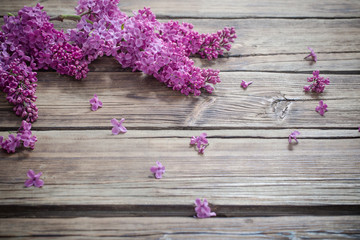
(0, 216), (360, 239)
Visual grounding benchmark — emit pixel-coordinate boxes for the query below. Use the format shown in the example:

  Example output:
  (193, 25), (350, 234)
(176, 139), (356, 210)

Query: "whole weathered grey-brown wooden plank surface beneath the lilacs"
(0, 0), (360, 239)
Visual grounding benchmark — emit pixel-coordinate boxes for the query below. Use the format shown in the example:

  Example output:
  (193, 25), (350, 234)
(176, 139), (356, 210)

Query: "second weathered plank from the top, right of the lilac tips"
(0, 19), (360, 56)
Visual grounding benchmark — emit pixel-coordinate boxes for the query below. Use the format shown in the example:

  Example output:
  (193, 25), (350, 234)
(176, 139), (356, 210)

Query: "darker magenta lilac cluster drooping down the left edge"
(0, 4), (88, 122)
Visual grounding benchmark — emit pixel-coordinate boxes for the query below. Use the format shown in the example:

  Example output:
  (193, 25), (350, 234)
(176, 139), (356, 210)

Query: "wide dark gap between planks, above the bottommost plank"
(0, 203), (360, 219)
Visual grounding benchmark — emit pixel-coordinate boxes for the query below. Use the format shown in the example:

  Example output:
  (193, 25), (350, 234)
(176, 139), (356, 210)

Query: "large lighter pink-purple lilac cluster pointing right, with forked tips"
(69, 0), (236, 95)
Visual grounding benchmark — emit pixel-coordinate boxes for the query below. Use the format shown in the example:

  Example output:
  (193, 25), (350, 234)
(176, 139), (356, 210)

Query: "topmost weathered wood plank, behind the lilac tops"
(0, 0), (360, 18)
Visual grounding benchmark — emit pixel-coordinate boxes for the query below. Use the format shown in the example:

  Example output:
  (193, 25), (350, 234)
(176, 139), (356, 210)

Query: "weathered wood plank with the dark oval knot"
(0, 72), (360, 130)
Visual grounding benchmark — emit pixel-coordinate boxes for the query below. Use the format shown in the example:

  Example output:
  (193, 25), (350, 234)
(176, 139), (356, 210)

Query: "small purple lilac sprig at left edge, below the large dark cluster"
(0, 121), (37, 153)
